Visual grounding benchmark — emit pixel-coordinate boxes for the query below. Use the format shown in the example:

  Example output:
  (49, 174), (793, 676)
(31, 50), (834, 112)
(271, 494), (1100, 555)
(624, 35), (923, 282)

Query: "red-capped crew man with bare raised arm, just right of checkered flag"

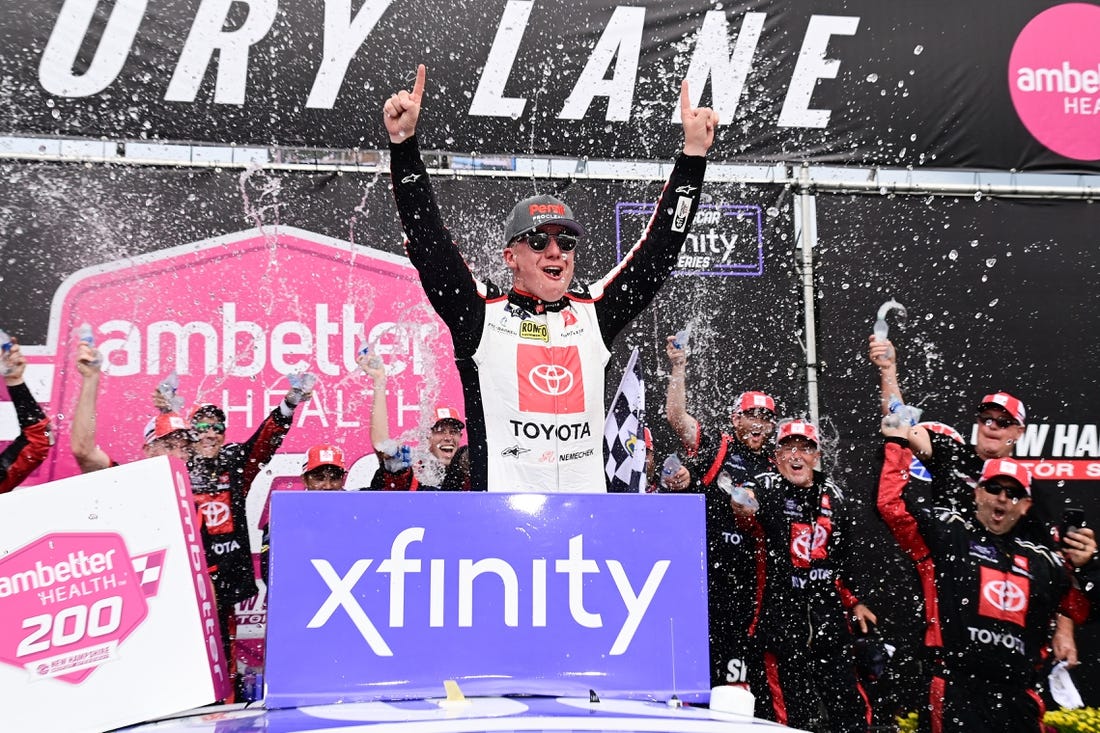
(661, 336), (776, 687)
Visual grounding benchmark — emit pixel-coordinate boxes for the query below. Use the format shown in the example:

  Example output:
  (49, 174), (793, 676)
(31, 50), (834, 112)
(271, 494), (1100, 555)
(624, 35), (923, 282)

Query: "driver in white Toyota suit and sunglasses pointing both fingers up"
(384, 65), (717, 492)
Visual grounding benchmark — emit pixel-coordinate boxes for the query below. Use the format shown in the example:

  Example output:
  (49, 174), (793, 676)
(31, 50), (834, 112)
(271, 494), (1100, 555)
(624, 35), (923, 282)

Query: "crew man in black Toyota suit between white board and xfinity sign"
(187, 378), (311, 688)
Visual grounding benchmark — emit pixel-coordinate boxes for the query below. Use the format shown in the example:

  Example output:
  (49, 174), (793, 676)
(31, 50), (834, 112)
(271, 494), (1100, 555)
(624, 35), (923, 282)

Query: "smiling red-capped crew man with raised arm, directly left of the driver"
(359, 355), (471, 491)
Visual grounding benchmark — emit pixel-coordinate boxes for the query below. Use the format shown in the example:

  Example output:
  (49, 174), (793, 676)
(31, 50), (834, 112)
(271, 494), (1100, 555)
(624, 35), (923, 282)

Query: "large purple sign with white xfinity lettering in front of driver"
(266, 492), (710, 707)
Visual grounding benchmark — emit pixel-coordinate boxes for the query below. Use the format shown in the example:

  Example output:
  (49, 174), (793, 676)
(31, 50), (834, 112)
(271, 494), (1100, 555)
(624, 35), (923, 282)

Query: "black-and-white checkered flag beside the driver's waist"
(604, 348), (646, 493)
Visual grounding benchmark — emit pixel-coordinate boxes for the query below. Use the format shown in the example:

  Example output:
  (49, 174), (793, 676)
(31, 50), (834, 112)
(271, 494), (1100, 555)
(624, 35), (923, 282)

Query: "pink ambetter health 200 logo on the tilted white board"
(0, 533), (165, 683)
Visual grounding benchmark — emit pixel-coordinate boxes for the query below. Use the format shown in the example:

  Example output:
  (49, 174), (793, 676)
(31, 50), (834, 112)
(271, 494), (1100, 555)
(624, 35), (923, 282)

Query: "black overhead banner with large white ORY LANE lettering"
(0, 0), (1100, 171)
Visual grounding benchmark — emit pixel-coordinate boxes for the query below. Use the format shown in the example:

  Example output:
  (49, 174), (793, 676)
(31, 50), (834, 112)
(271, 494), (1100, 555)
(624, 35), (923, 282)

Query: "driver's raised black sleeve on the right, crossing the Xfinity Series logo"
(595, 153), (706, 348)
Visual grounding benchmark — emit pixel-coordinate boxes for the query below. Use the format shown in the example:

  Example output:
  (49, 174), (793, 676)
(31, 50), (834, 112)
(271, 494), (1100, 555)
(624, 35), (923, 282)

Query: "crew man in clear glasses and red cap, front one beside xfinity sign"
(739, 419), (877, 733)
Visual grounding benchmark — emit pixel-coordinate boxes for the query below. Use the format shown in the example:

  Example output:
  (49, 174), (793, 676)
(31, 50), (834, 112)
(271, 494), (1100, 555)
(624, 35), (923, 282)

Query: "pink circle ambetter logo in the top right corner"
(1009, 2), (1100, 161)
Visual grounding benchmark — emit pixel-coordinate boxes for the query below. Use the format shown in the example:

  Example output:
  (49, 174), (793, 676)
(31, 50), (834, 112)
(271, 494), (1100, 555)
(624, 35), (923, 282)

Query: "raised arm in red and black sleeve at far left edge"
(0, 343), (53, 494)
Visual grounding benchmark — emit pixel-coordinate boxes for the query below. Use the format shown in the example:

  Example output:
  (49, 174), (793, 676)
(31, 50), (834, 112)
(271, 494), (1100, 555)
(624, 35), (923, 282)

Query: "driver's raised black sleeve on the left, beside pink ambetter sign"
(389, 135), (485, 359)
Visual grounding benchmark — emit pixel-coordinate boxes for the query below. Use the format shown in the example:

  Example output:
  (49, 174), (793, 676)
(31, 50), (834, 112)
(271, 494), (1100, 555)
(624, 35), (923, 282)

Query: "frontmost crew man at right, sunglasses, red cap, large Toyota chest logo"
(879, 416), (1100, 733)
